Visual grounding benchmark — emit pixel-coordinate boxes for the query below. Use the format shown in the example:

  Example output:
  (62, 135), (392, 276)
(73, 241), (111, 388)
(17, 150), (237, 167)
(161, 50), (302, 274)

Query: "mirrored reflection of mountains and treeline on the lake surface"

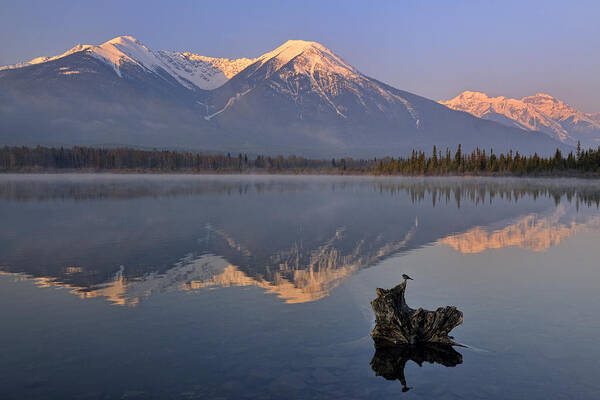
(0, 175), (600, 306)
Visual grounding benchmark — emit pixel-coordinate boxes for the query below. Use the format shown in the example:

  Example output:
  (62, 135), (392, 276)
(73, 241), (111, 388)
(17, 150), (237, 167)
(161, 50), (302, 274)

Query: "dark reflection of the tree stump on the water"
(371, 343), (462, 392)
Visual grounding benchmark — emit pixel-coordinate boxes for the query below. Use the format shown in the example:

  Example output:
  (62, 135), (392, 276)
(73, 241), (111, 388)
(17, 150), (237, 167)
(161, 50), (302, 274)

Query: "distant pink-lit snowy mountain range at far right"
(440, 91), (600, 147)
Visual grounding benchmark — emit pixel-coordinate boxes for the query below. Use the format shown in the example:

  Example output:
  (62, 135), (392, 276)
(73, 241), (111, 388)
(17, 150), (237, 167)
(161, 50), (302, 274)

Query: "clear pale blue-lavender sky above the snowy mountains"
(0, 0), (600, 112)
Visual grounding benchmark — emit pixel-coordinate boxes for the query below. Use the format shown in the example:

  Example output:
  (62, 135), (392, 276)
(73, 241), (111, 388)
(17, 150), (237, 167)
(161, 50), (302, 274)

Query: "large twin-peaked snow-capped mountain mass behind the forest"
(0, 36), (568, 157)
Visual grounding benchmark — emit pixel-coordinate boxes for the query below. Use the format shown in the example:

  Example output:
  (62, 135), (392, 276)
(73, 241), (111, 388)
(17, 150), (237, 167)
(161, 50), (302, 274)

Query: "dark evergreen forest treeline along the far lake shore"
(0, 145), (600, 176)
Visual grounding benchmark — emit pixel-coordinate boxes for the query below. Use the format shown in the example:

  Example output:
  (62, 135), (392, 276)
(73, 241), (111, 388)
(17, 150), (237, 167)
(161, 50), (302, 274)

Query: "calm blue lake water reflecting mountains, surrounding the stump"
(0, 174), (600, 400)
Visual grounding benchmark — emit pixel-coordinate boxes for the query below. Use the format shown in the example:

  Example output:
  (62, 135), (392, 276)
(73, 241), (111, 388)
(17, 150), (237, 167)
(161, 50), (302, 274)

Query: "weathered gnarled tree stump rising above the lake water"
(371, 280), (462, 348)
